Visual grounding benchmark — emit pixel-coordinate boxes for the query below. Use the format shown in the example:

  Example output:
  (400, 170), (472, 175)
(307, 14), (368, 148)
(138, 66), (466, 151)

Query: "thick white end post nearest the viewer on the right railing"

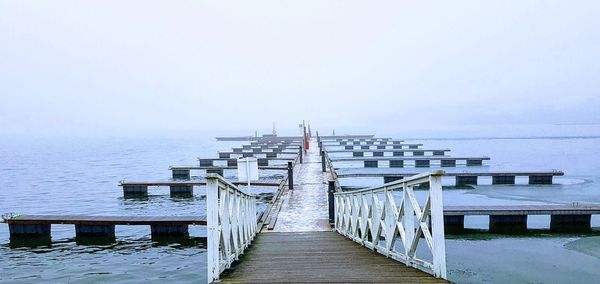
(429, 175), (447, 279)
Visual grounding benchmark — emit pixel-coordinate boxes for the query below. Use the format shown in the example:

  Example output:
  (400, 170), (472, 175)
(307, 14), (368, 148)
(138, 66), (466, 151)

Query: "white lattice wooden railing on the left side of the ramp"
(206, 174), (257, 283)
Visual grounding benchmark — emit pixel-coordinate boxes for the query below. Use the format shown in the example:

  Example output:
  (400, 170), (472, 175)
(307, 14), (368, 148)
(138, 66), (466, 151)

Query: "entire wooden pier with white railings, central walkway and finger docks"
(5, 129), (588, 283)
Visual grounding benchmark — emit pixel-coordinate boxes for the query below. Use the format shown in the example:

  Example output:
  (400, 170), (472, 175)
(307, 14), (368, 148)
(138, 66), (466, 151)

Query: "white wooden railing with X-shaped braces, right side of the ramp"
(334, 171), (446, 279)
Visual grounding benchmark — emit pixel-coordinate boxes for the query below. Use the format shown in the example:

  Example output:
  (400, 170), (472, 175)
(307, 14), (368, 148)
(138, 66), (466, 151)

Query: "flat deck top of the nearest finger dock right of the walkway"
(444, 204), (600, 216)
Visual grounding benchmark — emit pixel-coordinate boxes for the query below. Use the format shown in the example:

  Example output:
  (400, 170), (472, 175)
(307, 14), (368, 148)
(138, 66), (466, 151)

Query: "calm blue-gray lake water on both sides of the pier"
(0, 125), (600, 283)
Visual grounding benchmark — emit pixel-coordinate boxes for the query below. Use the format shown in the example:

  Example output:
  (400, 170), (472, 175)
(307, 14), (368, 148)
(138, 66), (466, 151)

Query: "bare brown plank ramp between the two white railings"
(221, 232), (448, 283)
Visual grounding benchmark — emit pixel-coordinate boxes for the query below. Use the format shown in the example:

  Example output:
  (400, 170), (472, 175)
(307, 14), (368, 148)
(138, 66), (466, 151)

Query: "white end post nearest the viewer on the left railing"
(206, 177), (220, 283)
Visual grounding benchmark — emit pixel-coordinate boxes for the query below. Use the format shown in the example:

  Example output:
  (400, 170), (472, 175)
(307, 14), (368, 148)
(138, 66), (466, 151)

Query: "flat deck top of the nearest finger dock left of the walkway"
(4, 215), (206, 225)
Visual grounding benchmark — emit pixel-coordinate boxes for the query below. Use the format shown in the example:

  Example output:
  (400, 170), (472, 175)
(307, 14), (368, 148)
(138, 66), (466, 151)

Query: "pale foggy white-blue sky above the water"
(0, 0), (600, 137)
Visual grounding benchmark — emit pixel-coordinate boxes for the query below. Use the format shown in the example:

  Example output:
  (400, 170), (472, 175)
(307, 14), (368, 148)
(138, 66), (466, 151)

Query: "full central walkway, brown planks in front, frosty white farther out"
(220, 143), (447, 283)
